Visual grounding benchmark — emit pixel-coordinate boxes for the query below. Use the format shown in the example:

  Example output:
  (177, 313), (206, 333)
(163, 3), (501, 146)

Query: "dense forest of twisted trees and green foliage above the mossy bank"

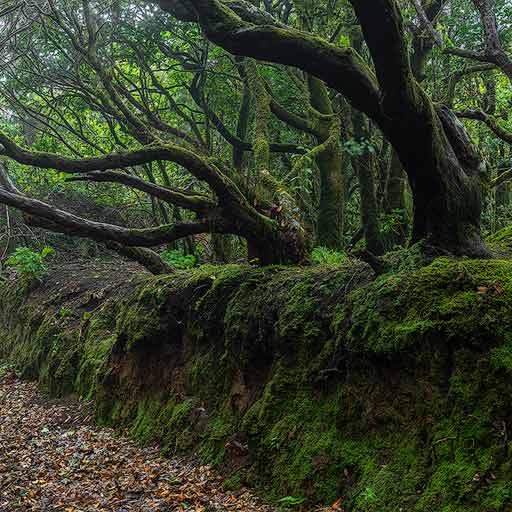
(0, 0), (512, 273)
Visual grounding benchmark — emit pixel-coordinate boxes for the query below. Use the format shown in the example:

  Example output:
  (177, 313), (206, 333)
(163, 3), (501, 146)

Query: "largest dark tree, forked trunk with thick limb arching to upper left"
(161, 0), (487, 256)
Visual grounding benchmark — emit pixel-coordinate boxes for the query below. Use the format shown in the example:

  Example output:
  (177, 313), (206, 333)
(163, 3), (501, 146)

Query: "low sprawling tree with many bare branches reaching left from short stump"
(0, 1), (316, 264)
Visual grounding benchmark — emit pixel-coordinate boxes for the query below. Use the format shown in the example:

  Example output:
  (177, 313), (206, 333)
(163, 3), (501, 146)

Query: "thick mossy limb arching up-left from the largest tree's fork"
(161, 0), (386, 125)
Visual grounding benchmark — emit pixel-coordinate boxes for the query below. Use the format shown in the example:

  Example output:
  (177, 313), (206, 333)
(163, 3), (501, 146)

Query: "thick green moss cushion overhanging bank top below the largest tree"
(338, 258), (512, 352)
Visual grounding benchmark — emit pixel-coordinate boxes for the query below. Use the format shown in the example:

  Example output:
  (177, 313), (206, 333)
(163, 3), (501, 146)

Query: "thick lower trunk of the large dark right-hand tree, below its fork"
(394, 106), (488, 257)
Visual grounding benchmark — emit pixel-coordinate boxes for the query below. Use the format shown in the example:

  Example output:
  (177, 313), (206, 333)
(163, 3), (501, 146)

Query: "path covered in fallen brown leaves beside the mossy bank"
(0, 376), (273, 512)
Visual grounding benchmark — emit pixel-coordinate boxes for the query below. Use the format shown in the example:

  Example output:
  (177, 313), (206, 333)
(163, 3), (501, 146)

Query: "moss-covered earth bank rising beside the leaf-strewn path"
(0, 258), (512, 512)
